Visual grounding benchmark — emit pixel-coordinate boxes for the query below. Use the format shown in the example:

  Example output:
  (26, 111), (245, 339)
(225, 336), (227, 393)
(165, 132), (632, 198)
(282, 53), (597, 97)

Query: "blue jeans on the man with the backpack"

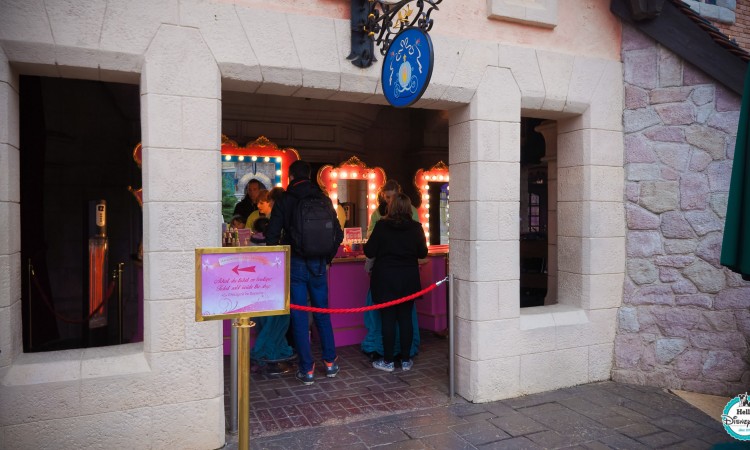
(290, 256), (336, 373)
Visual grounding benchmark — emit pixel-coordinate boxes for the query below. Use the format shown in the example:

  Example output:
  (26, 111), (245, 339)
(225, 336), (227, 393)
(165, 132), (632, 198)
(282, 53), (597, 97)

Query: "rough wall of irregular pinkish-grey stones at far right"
(613, 26), (750, 395)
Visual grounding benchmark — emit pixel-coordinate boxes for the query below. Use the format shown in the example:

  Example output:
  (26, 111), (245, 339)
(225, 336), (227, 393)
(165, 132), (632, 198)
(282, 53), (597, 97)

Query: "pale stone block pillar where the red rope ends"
(449, 67), (521, 401)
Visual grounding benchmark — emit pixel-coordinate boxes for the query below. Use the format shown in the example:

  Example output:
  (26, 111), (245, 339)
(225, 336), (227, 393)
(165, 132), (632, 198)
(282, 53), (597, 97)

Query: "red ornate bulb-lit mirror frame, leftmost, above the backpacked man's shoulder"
(221, 135), (299, 190)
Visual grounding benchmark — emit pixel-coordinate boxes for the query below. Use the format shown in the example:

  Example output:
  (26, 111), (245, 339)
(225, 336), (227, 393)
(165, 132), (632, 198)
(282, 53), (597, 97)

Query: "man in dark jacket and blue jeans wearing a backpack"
(266, 160), (344, 385)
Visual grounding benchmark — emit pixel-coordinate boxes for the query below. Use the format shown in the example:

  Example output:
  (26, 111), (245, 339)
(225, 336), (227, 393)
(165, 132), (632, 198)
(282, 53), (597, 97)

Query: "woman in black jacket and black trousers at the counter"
(365, 193), (427, 372)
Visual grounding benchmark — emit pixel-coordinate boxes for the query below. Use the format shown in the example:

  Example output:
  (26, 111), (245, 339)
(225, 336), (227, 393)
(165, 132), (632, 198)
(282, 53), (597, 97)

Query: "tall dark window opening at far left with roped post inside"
(17, 75), (143, 353)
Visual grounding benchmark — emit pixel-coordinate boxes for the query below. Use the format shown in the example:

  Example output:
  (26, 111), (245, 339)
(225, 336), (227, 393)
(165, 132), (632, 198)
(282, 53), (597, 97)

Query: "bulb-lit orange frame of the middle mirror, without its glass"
(318, 156), (385, 229)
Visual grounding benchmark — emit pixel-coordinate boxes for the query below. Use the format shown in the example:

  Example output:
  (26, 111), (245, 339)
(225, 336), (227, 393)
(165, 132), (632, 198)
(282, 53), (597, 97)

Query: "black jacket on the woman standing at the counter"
(365, 219), (427, 303)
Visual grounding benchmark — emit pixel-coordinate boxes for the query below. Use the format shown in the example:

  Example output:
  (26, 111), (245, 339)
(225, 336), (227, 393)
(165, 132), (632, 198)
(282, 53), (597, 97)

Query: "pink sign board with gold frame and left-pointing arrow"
(195, 245), (290, 322)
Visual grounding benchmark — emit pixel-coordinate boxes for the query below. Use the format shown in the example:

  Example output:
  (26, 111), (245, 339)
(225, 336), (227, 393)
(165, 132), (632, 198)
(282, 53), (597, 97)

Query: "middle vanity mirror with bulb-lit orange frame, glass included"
(318, 156), (385, 236)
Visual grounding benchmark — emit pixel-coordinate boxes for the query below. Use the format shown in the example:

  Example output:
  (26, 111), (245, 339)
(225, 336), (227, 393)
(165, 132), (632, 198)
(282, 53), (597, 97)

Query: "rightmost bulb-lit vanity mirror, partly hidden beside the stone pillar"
(414, 161), (450, 245)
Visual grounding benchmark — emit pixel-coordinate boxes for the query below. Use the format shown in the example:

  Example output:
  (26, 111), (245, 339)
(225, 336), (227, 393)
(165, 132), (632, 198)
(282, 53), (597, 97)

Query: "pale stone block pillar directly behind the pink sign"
(141, 25), (224, 448)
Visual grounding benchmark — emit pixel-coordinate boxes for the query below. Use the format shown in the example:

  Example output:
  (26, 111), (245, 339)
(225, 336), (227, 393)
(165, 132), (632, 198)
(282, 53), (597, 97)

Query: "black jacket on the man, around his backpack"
(265, 178), (344, 262)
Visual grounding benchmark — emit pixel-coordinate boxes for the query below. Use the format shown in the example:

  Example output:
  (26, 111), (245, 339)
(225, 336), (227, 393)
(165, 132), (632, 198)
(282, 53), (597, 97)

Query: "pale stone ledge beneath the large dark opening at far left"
(0, 342), (151, 386)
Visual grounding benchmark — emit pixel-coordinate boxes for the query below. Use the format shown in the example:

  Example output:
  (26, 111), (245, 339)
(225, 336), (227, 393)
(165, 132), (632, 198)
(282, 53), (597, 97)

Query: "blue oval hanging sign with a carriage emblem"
(380, 27), (433, 108)
